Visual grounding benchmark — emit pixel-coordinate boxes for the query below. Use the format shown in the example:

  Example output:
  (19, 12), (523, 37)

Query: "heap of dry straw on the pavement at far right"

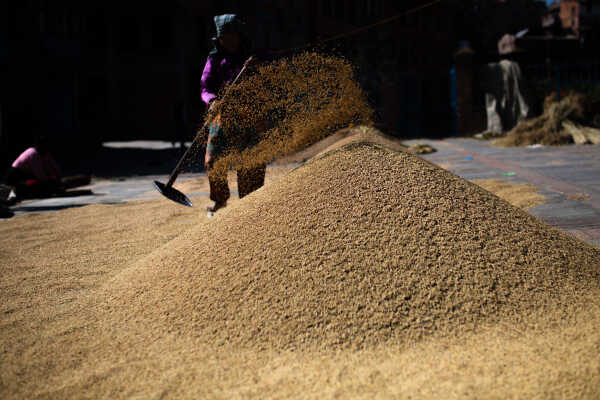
(492, 92), (600, 147)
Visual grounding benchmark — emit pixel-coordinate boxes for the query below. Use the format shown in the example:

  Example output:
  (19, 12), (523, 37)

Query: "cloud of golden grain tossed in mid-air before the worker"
(199, 53), (373, 175)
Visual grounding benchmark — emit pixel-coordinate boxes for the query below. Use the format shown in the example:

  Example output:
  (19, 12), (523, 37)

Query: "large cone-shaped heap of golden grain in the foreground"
(99, 142), (600, 349)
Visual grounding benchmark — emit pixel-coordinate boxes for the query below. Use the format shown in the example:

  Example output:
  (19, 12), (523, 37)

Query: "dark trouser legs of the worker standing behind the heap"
(208, 165), (267, 204)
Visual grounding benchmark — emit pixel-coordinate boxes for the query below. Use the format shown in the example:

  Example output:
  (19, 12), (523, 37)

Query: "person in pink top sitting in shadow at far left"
(5, 136), (90, 201)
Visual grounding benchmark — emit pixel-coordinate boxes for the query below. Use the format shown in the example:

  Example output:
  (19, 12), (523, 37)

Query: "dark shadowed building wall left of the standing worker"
(0, 0), (247, 167)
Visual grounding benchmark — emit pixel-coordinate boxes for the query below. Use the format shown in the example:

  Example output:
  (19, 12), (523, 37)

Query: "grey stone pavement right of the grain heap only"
(405, 138), (600, 246)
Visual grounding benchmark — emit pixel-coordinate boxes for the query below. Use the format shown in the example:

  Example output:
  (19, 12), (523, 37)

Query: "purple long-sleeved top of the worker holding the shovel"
(200, 53), (245, 107)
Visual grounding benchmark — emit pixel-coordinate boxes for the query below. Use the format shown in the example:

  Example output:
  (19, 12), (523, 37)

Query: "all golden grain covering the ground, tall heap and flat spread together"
(0, 142), (600, 399)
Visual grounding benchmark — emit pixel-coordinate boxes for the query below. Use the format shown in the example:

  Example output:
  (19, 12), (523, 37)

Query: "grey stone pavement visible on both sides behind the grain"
(4, 138), (600, 246)
